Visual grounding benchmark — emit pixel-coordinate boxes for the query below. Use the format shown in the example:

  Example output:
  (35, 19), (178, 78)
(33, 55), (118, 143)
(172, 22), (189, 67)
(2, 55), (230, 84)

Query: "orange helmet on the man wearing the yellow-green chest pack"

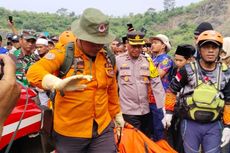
(197, 30), (223, 47)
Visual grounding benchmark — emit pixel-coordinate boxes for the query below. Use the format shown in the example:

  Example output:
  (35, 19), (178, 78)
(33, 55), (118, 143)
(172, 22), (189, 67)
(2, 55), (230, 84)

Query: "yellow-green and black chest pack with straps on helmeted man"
(185, 62), (226, 122)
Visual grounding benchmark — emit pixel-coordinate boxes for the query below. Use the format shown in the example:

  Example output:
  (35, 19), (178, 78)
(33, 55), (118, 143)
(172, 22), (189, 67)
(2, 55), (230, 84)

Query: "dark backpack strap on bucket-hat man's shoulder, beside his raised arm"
(58, 42), (75, 78)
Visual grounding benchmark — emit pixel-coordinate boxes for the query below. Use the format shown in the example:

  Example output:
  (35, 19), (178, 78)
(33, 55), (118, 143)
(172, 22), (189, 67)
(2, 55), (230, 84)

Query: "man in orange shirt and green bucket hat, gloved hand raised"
(27, 8), (124, 153)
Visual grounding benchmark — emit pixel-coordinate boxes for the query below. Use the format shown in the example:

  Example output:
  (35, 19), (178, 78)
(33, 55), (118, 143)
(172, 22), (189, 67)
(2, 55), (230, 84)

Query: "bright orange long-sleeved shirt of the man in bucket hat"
(27, 44), (120, 138)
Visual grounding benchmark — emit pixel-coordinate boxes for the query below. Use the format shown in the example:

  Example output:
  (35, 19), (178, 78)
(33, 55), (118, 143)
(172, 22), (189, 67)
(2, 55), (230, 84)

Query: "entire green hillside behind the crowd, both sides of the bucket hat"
(0, 0), (230, 52)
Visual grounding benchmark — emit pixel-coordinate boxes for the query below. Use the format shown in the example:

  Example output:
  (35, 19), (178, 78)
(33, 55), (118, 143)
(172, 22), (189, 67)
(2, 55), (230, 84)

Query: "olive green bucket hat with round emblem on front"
(71, 8), (115, 44)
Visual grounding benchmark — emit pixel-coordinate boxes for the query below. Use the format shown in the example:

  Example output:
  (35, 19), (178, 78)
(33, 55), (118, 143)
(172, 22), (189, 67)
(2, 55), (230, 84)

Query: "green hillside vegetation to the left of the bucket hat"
(0, 8), (77, 35)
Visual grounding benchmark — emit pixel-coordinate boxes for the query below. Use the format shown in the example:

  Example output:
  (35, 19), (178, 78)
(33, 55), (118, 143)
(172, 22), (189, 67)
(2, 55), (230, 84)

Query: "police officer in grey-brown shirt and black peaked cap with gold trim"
(116, 31), (165, 136)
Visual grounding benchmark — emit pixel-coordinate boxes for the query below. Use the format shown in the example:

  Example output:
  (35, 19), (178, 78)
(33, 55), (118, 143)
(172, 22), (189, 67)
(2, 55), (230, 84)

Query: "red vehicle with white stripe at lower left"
(0, 85), (53, 153)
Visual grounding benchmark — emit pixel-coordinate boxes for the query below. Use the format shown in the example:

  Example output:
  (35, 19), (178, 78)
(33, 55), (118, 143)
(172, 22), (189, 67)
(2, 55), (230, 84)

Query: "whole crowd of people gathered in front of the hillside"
(0, 8), (230, 153)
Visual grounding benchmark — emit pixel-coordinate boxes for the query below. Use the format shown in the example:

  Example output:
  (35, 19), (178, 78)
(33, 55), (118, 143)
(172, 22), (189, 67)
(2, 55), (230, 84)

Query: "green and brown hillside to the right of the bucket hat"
(109, 0), (230, 51)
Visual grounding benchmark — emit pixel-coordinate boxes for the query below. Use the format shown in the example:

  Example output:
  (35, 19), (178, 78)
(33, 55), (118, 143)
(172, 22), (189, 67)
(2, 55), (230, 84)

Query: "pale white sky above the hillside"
(0, 0), (201, 16)
